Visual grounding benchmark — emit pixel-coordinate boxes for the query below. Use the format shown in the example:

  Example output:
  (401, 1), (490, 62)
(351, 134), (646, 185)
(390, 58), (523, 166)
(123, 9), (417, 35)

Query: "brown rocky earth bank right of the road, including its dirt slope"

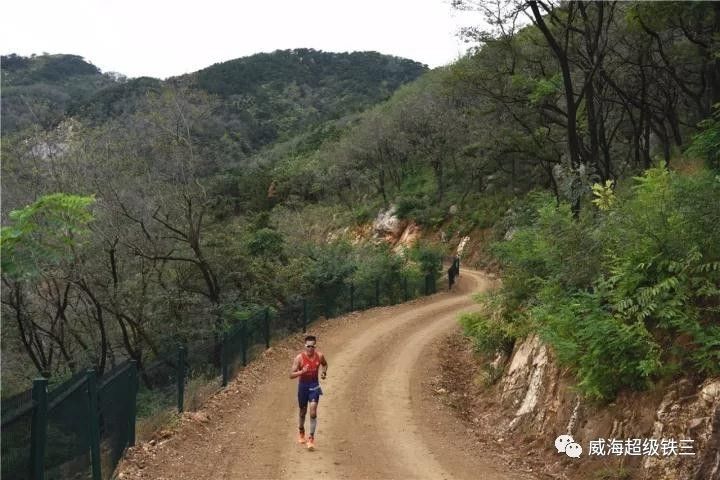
(436, 335), (720, 480)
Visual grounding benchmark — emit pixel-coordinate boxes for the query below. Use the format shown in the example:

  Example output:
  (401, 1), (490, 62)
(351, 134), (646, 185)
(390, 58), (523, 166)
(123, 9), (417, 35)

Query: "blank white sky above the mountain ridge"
(0, 0), (490, 78)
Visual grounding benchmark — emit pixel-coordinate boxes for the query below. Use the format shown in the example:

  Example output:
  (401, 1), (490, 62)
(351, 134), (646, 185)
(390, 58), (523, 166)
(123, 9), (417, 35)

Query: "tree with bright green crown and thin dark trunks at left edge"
(0, 193), (101, 375)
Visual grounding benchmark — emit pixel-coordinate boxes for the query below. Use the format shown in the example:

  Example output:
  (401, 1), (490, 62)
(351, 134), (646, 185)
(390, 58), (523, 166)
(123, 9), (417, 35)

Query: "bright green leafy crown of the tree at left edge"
(0, 193), (95, 278)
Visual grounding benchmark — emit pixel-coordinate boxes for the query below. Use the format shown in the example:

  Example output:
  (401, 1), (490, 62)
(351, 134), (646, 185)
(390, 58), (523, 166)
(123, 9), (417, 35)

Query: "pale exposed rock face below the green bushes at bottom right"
(495, 335), (720, 480)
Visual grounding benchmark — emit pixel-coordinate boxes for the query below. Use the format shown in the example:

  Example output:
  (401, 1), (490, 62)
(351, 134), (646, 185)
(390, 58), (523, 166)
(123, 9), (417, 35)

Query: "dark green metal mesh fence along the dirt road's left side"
(0, 263), (459, 480)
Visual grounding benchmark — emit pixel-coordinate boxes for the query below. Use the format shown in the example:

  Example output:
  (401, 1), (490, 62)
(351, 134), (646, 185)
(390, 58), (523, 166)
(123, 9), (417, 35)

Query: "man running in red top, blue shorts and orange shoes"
(290, 335), (327, 450)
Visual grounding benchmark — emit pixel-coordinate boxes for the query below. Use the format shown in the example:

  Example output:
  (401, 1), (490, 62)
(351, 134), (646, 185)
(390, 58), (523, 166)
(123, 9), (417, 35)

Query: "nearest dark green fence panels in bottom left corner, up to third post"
(0, 361), (137, 480)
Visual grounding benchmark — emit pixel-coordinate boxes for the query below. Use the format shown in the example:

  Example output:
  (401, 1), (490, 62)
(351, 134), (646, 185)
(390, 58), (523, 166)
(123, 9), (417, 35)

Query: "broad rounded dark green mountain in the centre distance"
(193, 49), (426, 148)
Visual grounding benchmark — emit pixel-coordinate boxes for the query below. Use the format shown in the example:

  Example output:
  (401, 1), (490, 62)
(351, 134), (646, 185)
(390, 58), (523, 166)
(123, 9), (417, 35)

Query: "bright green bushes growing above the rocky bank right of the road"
(472, 165), (720, 399)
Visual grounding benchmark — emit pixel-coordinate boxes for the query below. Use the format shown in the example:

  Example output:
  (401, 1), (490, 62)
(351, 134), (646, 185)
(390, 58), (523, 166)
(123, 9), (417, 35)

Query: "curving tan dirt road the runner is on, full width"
(124, 270), (532, 480)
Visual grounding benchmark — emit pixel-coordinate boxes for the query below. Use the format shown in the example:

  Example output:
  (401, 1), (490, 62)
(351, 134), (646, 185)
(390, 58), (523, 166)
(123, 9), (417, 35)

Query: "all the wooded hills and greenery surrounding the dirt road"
(2, 1), (720, 420)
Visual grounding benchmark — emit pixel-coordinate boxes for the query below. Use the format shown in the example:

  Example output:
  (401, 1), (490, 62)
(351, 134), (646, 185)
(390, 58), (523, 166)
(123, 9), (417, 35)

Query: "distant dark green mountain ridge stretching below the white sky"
(2, 49), (427, 156)
